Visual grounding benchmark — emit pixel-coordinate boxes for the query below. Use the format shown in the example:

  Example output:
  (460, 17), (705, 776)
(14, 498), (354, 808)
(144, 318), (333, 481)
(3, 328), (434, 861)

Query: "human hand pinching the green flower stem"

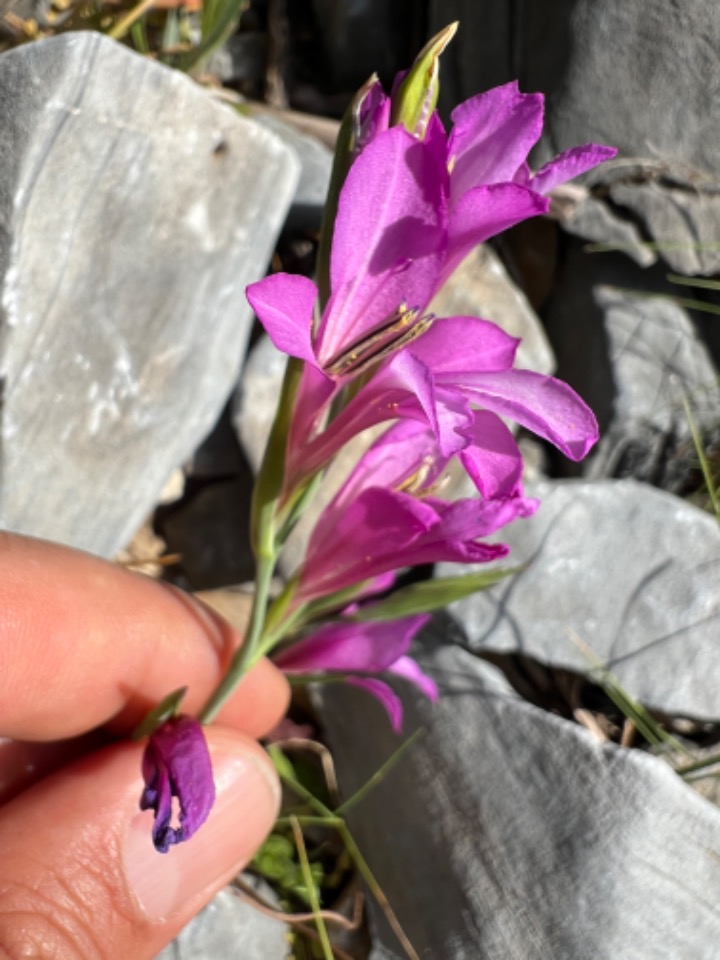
(0, 534), (288, 960)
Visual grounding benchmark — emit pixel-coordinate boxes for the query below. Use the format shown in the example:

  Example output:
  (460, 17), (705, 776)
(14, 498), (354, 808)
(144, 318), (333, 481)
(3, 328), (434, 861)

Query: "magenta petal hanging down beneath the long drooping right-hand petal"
(458, 410), (523, 499)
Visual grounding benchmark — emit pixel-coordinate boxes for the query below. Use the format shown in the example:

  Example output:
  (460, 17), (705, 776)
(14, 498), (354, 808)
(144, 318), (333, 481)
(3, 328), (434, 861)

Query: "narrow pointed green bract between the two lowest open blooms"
(354, 567), (525, 620)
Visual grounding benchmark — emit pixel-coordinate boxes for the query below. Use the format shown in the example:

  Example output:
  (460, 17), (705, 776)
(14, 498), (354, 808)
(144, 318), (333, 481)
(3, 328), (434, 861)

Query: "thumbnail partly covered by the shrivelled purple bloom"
(122, 738), (280, 922)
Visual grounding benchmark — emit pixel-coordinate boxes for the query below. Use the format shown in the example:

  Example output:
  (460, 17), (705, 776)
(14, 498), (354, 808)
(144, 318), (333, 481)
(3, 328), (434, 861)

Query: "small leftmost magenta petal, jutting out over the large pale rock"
(245, 273), (317, 366)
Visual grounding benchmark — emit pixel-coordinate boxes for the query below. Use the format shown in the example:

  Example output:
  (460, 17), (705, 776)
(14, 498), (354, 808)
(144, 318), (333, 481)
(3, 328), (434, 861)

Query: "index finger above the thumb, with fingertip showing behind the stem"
(0, 533), (289, 740)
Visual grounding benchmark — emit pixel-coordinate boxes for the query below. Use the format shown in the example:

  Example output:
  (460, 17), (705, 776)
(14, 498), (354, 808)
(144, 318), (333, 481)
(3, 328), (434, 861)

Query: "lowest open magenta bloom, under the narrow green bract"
(273, 614), (438, 733)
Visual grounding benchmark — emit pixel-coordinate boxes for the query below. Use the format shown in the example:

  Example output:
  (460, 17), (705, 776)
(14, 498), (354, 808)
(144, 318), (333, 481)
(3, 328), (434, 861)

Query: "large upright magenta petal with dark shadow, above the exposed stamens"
(316, 127), (447, 366)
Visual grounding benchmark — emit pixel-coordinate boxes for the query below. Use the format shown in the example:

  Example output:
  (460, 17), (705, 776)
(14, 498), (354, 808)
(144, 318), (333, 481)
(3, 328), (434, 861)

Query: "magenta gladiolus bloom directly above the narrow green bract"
(295, 411), (538, 603)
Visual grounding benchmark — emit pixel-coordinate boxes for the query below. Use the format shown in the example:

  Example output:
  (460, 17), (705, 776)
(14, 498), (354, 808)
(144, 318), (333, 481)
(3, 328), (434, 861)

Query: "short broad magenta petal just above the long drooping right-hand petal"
(408, 317), (520, 374)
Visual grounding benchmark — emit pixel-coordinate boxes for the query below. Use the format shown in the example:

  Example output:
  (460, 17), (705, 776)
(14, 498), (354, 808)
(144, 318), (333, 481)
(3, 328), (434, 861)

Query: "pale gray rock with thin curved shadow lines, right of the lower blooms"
(437, 480), (720, 721)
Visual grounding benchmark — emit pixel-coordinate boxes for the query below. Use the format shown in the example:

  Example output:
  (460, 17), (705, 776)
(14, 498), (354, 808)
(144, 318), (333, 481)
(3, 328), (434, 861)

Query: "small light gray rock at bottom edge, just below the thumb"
(156, 888), (288, 960)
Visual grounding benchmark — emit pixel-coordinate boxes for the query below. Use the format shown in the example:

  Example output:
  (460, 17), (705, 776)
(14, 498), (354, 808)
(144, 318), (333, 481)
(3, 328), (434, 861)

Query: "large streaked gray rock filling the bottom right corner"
(317, 622), (720, 960)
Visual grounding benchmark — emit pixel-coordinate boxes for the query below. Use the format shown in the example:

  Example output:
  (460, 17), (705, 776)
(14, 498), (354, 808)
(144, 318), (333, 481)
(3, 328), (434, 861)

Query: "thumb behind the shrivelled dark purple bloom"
(0, 727), (280, 960)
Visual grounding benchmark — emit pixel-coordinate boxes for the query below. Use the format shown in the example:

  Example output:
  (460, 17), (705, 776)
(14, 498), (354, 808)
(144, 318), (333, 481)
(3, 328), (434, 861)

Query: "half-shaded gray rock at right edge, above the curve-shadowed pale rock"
(545, 242), (720, 491)
